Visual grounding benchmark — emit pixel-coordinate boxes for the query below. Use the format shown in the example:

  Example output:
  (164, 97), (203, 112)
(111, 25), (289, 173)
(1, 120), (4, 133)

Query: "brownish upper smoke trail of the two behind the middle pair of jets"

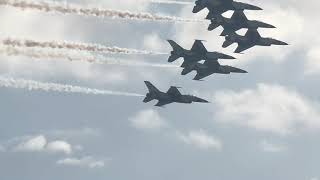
(0, 38), (166, 55)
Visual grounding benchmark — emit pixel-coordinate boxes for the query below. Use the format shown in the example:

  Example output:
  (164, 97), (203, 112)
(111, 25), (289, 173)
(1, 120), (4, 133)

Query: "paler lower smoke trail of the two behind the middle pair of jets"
(0, 45), (178, 68)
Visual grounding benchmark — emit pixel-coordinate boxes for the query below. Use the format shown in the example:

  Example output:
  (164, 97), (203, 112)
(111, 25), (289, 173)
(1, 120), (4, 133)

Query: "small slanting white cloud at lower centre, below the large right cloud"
(177, 130), (223, 151)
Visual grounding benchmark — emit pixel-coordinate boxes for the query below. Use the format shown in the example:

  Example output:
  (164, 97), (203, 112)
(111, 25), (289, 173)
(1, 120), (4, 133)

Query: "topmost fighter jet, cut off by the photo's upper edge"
(192, 0), (262, 18)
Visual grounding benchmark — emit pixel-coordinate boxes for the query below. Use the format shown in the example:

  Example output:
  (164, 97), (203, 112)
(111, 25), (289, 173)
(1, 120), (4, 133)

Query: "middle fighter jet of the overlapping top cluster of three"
(208, 10), (275, 36)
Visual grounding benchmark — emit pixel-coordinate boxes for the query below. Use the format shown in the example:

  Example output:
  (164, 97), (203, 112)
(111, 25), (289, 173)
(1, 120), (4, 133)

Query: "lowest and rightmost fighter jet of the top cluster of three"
(222, 29), (288, 53)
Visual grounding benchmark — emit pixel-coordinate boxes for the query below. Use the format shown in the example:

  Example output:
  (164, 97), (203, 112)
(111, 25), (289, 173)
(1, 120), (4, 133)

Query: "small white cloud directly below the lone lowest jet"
(129, 109), (167, 130)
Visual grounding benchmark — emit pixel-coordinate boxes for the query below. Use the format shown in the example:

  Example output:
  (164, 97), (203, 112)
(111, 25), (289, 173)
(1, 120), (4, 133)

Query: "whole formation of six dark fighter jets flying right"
(143, 0), (288, 107)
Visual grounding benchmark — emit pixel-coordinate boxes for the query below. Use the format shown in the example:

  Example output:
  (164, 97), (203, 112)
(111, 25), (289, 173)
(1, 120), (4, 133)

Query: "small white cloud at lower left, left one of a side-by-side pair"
(15, 135), (47, 152)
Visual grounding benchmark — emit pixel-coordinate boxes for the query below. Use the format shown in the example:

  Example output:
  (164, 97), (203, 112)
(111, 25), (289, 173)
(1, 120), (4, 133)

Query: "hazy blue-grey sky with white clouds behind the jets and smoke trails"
(0, 0), (320, 180)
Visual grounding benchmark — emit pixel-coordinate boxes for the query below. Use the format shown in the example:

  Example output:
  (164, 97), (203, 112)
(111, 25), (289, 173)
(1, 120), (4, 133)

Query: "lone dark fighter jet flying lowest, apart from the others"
(143, 81), (208, 107)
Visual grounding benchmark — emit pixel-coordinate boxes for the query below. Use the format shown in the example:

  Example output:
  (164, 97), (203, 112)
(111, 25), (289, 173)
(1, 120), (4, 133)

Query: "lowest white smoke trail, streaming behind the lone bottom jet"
(0, 76), (144, 97)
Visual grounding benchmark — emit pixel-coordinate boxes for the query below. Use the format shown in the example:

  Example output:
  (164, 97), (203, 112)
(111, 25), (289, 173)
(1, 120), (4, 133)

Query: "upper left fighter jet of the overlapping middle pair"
(168, 40), (235, 67)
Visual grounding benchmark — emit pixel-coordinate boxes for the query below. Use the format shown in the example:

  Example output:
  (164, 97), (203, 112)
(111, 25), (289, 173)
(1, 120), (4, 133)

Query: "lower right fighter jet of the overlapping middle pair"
(181, 61), (248, 81)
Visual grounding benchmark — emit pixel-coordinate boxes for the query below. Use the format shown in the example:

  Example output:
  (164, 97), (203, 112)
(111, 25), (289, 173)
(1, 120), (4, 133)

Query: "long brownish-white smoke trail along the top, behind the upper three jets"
(0, 0), (202, 22)
